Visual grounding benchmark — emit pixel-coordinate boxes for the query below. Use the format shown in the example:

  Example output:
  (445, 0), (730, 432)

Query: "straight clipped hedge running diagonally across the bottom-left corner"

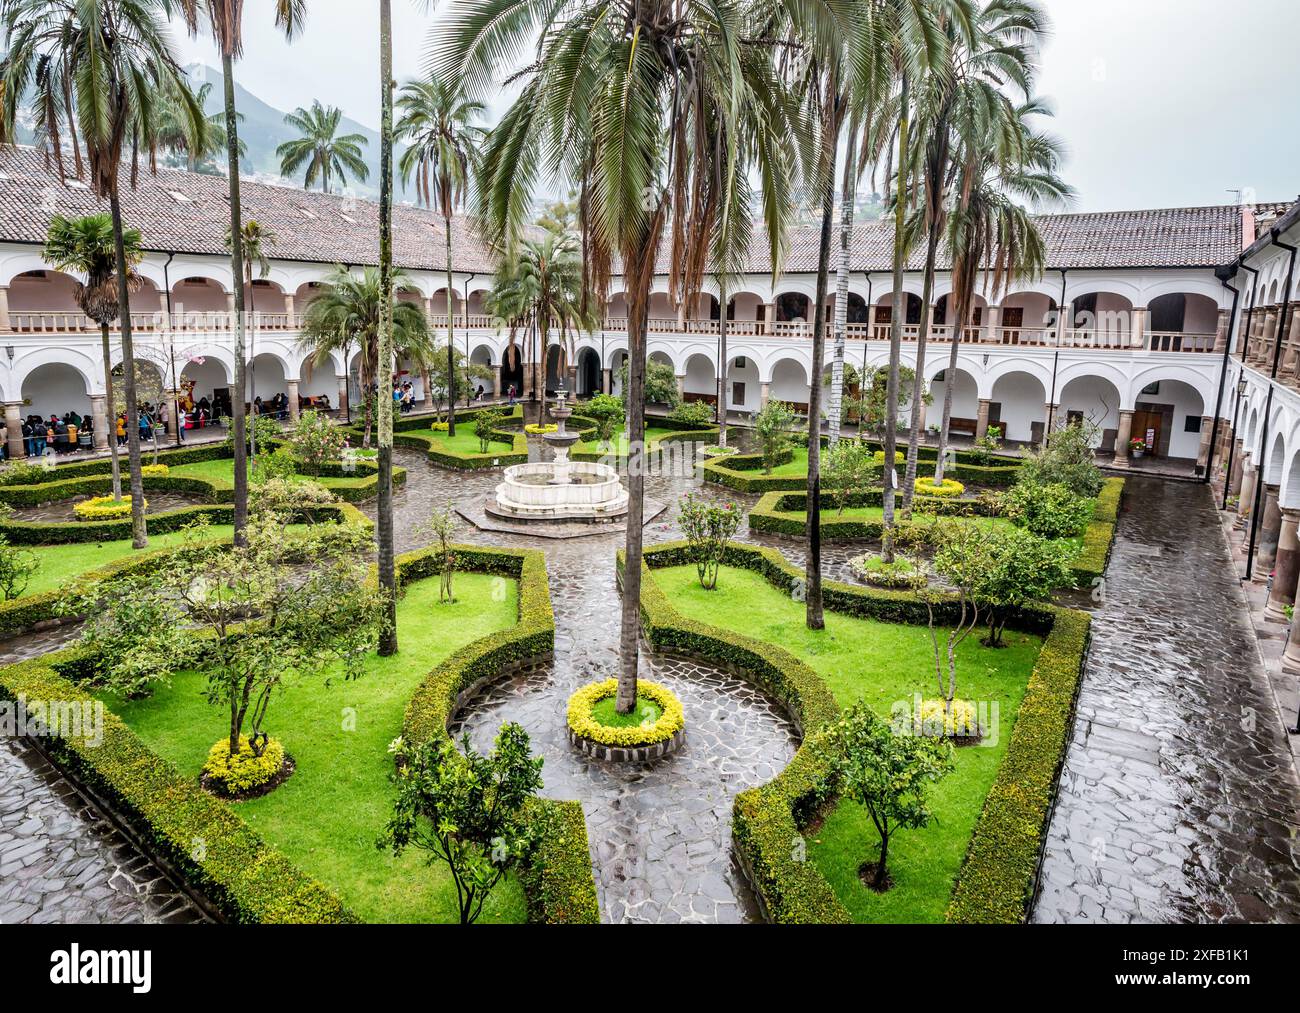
(0, 649), (358, 923)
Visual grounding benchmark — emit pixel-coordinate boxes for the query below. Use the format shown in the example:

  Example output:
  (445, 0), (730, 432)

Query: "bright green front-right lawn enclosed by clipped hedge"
(653, 566), (1041, 922)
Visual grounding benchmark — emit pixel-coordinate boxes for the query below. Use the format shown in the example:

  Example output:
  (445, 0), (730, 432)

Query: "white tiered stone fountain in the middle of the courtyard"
(486, 388), (628, 521)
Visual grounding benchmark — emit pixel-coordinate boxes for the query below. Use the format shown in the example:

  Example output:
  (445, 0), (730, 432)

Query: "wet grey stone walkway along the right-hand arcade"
(1034, 477), (1300, 923)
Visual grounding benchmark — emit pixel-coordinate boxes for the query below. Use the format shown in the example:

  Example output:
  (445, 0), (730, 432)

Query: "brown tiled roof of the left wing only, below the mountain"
(0, 147), (493, 272)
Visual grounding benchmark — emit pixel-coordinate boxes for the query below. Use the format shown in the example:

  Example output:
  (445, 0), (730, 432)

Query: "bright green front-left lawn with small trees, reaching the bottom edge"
(108, 573), (525, 922)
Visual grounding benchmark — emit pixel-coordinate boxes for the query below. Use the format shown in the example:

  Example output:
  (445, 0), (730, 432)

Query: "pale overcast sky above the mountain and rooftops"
(178, 0), (1300, 211)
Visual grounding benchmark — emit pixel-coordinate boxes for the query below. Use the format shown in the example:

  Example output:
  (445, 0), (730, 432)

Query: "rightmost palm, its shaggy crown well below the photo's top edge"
(935, 105), (1073, 481)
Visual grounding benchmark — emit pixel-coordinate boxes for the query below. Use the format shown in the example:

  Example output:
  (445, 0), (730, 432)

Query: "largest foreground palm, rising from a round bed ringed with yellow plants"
(432, 0), (795, 714)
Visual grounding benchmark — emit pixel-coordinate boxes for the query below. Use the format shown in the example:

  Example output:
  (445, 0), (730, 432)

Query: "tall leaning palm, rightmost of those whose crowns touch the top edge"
(904, 0), (1047, 511)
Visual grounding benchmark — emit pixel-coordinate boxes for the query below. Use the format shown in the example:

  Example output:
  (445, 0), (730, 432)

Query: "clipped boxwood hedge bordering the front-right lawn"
(641, 542), (1091, 923)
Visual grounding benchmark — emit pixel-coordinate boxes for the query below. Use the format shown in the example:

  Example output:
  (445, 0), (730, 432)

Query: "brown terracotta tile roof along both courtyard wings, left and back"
(0, 147), (1258, 273)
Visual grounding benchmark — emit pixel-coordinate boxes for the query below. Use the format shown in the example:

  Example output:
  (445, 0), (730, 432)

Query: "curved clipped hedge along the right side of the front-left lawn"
(397, 545), (601, 923)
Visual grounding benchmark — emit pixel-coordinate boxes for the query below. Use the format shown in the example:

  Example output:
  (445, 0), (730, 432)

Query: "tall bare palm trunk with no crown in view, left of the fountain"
(376, 0), (395, 657)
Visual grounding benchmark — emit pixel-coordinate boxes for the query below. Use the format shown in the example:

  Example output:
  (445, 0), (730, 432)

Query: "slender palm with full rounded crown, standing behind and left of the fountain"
(398, 77), (485, 436)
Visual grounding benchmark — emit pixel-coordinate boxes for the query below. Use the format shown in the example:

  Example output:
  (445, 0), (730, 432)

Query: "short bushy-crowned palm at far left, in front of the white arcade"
(42, 215), (144, 499)
